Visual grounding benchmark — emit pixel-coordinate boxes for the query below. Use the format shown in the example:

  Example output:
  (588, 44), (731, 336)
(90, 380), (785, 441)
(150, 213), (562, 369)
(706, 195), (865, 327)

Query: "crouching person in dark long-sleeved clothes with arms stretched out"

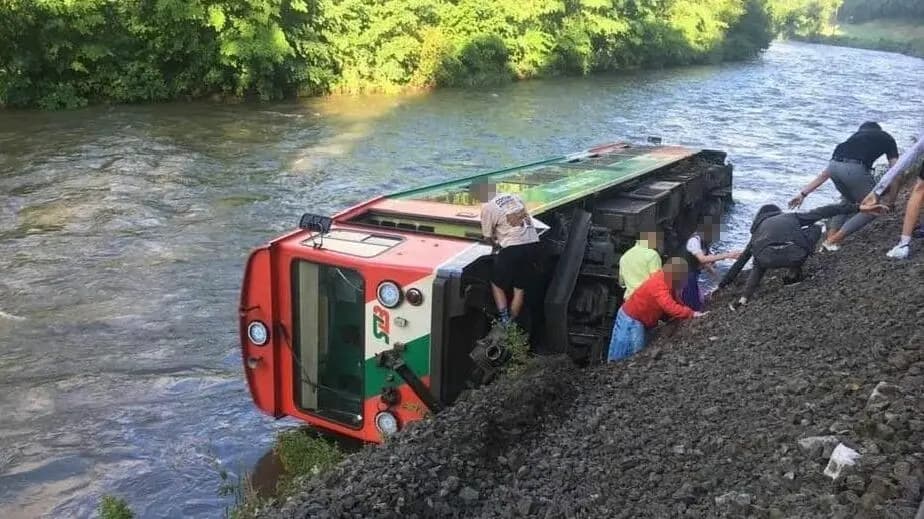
(719, 203), (857, 310)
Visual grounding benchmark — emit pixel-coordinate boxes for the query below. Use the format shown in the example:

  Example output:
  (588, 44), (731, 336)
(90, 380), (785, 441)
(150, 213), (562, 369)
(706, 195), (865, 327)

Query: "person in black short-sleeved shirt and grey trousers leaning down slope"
(789, 121), (898, 251)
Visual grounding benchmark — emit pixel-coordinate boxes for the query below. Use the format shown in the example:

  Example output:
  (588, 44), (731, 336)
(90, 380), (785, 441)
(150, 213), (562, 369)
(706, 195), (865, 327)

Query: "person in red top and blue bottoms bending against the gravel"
(607, 258), (705, 362)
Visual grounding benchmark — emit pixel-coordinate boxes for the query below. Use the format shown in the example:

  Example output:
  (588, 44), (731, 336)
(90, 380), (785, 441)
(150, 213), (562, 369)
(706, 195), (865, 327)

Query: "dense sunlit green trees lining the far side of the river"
(0, 0), (839, 108)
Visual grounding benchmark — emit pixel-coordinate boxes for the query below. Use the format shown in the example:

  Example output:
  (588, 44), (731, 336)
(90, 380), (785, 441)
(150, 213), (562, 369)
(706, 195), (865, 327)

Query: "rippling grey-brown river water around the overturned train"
(0, 43), (924, 518)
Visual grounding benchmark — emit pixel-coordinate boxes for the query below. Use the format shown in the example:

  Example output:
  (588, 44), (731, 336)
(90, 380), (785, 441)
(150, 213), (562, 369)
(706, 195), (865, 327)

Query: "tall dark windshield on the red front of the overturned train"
(292, 260), (365, 428)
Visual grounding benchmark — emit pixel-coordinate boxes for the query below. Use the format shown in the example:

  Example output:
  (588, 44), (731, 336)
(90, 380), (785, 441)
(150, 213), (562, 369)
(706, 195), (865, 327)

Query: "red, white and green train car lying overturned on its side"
(239, 143), (732, 442)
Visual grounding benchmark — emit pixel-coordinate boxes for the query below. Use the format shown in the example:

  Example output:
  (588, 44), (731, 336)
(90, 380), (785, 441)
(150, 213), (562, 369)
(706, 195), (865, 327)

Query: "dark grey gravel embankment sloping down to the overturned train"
(269, 207), (924, 519)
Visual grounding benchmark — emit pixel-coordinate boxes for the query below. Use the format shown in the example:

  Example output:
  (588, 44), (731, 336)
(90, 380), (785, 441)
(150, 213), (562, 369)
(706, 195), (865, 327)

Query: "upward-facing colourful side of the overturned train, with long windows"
(334, 143), (701, 239)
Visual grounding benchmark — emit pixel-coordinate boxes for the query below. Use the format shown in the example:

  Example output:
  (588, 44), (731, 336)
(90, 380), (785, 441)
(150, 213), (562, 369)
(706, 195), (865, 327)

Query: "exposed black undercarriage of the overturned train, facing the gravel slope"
(431, 152), (732, 401)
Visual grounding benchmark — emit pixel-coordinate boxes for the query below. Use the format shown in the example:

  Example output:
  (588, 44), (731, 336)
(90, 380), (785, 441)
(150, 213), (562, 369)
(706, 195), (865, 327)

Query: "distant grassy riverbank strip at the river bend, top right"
(806, 20), (924, 58)
